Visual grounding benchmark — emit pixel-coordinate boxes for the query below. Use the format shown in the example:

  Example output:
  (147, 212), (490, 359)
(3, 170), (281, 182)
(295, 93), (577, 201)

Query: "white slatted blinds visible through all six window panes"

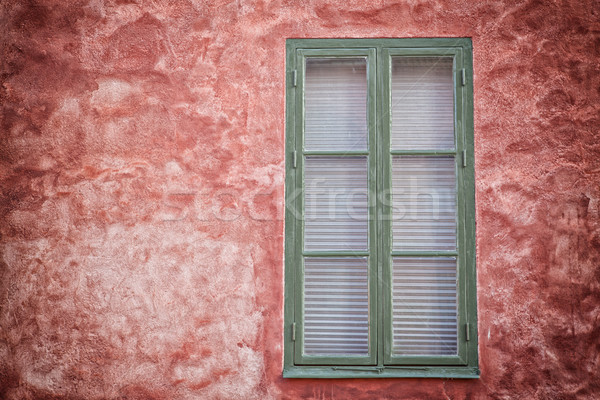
(303, 53), (457, 356)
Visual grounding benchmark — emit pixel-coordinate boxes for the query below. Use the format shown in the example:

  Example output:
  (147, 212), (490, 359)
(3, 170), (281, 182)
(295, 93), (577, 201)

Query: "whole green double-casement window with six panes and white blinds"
(283, 39), (479, 378)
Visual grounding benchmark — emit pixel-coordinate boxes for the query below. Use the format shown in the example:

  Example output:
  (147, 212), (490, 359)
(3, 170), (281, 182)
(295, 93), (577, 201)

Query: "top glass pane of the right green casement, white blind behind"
(391, 57), (454, 150)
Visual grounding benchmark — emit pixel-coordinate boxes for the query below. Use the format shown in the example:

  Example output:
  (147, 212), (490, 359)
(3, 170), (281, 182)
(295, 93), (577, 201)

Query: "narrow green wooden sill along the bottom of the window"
(283, 366), (479, 379)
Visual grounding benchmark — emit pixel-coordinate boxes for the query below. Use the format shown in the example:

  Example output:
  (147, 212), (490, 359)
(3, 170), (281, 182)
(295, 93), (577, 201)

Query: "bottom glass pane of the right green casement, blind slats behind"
(392, 257), (457, 356)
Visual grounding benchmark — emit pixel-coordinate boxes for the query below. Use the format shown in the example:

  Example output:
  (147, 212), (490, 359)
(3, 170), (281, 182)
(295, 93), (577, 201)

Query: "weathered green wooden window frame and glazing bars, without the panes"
(283, 38), (479, 378)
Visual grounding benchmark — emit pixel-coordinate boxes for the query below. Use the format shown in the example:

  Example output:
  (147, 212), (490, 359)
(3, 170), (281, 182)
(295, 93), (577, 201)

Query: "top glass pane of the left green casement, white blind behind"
(304, 58), (368, 150)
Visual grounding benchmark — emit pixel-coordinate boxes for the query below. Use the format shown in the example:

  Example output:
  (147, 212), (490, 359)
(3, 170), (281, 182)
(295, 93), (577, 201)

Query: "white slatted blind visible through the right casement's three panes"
(391, 57), (458, 356)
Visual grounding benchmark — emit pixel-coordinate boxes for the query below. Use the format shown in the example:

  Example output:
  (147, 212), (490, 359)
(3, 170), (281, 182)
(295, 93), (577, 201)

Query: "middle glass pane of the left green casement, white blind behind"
(304, 157), (369, 251)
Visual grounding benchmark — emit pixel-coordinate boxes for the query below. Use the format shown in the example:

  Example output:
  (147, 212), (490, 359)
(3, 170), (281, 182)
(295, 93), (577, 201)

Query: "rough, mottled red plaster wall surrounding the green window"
(0, 0), (600, 399)
